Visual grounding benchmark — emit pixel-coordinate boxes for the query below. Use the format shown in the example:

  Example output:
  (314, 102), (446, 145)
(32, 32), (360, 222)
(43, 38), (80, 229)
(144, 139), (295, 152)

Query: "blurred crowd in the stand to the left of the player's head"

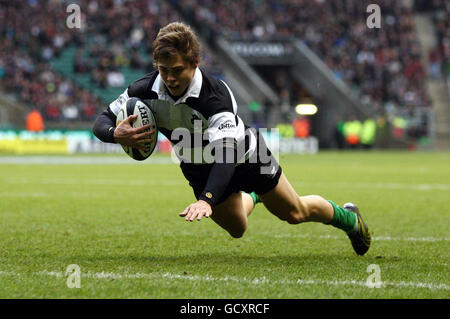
(0, 0), (221, 121)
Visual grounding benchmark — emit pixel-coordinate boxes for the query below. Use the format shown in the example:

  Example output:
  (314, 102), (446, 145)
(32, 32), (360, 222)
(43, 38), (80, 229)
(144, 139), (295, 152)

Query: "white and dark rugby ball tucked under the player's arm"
(116, 97), (158, 161)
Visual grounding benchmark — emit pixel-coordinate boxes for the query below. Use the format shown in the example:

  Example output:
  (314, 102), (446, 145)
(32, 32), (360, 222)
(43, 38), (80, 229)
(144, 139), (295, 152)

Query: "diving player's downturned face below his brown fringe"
(156, 53), (197, 96)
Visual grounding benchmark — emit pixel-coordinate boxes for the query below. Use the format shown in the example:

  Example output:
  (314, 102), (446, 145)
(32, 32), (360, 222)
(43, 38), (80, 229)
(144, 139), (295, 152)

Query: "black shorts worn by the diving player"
(180, 134), (282, 204)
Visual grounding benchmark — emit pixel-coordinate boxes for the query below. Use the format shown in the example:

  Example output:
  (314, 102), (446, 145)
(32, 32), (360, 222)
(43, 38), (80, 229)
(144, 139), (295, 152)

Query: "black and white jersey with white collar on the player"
(107, 68), (256, 164)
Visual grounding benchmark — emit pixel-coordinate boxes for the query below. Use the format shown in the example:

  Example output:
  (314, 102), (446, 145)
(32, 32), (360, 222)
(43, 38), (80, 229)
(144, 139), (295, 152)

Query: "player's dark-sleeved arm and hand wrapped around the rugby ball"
(93, 90), (152, 150)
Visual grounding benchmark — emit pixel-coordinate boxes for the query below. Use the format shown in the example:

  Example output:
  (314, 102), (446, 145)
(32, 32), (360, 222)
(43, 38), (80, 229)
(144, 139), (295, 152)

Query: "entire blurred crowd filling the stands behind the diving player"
(0, 0), (450, 148)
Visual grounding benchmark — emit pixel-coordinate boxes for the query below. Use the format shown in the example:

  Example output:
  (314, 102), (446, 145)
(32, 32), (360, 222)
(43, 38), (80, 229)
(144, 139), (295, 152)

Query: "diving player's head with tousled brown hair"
(153, 22), (200, 96)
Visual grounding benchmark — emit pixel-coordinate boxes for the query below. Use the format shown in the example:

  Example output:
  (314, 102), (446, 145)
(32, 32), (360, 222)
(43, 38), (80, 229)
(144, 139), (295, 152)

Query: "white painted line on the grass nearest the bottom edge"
(0, 270), (450, 290)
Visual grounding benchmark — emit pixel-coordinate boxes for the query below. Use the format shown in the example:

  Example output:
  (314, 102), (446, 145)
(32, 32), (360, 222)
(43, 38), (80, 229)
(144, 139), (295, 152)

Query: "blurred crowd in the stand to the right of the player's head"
(172, 0), (430, 114)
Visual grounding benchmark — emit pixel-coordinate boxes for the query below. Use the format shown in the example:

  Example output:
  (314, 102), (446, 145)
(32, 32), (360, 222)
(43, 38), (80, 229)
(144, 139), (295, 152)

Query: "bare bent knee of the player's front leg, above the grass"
(211, 192), (254, 238)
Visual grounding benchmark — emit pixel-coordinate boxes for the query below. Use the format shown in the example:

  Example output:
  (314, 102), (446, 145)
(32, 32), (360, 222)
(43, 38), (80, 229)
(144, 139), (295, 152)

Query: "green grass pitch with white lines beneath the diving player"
(0, 152), (450, 299)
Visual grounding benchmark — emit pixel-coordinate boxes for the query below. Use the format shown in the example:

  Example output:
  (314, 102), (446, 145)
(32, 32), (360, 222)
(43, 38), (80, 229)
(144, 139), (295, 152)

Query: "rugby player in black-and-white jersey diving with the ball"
(93, 22), (371, 255)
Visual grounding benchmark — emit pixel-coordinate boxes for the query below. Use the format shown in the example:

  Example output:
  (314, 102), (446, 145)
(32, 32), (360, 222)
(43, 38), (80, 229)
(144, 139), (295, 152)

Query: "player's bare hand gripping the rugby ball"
(114, 115), (153, 150)
